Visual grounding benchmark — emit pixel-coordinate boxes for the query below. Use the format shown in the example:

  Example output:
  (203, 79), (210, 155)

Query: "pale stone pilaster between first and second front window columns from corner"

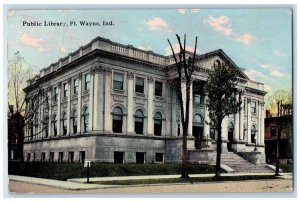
(127, 72), (134, 134)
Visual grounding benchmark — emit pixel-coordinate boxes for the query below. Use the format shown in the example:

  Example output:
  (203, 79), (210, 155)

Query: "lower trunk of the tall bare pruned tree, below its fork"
(181, 124), (189, 179)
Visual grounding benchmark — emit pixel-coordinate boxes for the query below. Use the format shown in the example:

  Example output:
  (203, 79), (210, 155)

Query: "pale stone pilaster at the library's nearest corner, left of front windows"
(104, 68), (112, 133)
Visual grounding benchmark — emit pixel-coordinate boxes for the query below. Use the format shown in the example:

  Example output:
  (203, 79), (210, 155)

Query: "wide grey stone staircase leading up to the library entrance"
(221, 152), (274, 173)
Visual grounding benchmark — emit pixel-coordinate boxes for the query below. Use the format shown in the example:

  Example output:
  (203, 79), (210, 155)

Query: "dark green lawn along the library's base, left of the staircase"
(9, 162), (220, 180)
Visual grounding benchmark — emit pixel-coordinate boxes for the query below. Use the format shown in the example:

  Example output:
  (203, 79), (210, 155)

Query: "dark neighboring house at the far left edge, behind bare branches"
(7, 105), (24, 161)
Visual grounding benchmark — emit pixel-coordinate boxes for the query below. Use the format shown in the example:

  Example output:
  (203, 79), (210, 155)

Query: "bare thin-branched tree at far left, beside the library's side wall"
(8, 52), (51, 162)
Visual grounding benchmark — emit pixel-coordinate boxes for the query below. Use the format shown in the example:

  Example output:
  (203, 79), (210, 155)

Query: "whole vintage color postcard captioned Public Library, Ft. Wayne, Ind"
(6, 6), (295, 197)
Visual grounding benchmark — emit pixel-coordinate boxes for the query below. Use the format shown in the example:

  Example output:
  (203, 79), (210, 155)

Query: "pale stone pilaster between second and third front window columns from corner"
(147, 77), (154, 135)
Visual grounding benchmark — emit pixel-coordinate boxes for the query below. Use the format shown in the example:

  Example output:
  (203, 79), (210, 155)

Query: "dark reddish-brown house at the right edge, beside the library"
(265, 110), (293, 163)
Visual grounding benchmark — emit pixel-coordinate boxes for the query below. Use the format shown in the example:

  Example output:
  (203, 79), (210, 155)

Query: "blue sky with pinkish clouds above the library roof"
(7, 8), (292, 94)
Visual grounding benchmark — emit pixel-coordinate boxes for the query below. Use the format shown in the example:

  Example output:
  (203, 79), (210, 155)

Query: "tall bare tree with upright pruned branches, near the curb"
(168, 34), (197, 178)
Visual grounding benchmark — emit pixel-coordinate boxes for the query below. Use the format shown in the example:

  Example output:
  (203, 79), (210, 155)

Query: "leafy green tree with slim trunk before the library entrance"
(206, 61), (242, 177)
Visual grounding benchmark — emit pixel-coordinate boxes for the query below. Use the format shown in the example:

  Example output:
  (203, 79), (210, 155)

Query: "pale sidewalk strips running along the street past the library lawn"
(8, 173), (293, 190)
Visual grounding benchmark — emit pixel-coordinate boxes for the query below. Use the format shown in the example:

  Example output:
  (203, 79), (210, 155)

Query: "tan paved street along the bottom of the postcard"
(9, 179), (293, 194)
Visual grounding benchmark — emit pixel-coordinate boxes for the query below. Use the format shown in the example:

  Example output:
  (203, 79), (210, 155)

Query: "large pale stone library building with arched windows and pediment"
(24, 37), (265, 163)
